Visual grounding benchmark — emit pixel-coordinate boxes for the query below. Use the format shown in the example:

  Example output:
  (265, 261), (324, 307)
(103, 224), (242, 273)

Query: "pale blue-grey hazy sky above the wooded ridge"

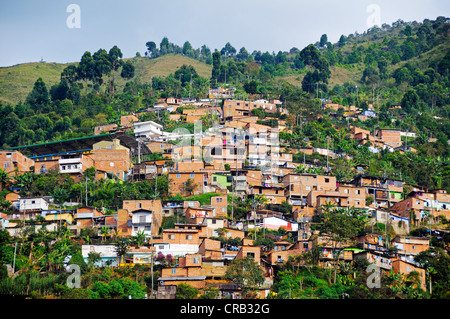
(0, 0), (450, 66)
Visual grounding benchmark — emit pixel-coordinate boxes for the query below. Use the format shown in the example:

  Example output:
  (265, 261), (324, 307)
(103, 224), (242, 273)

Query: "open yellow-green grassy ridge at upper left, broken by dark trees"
(0, 54), (212, 105)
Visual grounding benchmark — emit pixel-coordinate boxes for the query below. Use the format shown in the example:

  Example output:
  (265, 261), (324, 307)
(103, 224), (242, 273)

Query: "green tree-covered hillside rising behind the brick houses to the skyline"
(0, 17), (450, 191)
